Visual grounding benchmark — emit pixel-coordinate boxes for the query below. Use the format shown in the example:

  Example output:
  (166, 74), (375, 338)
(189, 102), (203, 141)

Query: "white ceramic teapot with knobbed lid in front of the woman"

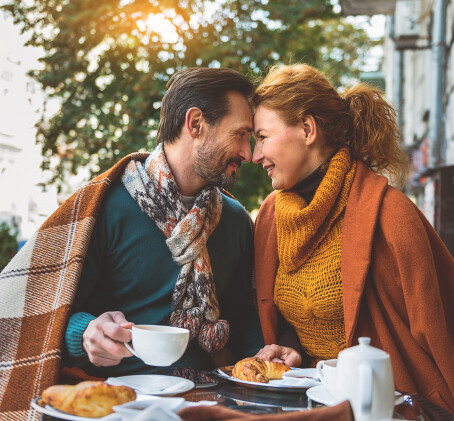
(336, 338), (394, 421)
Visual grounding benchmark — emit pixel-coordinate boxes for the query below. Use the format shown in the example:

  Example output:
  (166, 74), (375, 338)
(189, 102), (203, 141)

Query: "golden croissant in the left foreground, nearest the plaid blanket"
(42, 381), (136, 418)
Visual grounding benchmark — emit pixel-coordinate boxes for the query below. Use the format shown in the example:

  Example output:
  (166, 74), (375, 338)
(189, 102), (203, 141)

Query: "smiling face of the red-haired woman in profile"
(252, 105), (319, 190)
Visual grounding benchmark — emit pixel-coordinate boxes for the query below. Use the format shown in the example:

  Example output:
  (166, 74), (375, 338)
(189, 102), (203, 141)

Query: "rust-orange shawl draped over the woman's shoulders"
(254, 163), (454, 412)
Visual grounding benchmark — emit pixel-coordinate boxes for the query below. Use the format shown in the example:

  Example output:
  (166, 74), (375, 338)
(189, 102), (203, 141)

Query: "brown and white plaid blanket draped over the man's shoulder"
(0, 153), (149, 420)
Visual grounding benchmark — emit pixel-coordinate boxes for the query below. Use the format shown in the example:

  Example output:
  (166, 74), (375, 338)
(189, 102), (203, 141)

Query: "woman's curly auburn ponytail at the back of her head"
(343, 83), (410, 188)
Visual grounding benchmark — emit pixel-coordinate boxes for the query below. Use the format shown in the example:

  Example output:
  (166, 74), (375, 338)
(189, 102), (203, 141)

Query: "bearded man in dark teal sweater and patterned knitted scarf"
(66, 68), (260, 377)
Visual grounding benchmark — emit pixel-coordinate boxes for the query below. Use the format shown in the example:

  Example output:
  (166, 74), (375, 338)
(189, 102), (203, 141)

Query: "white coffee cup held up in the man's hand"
(125, 325), (189, 367)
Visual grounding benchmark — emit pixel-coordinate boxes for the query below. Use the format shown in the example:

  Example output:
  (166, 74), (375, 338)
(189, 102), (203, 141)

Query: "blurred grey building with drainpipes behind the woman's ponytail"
(341, 0), (454, 254)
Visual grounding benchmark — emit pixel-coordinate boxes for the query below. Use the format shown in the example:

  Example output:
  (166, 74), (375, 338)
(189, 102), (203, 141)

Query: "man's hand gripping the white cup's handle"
(82, 311), (134, 367)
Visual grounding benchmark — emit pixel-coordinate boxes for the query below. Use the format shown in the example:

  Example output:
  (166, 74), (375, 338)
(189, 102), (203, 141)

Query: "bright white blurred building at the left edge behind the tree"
(0, 10), (58, 243)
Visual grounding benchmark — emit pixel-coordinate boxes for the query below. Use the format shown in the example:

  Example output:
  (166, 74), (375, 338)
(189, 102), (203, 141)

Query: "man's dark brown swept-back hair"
(156, 67), (254, 143)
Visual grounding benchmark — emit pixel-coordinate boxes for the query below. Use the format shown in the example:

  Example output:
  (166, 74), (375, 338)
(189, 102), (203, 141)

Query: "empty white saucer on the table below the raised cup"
(106, 374), (194, 396)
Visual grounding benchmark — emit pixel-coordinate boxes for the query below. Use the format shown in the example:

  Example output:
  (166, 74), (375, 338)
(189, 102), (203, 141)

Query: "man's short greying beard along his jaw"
(194, 133), (241, 190)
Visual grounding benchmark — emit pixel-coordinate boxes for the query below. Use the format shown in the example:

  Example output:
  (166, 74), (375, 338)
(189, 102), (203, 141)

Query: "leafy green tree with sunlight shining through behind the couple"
(3, 0), (373, 209)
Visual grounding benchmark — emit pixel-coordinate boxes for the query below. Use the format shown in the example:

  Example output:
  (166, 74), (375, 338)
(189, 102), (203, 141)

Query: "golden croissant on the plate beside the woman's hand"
(232, 357), (290, 383)
